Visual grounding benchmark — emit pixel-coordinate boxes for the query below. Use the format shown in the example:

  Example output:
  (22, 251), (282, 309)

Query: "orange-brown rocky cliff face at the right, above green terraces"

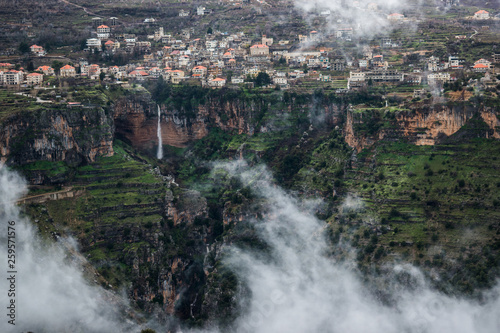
(344, 105), (500, 152)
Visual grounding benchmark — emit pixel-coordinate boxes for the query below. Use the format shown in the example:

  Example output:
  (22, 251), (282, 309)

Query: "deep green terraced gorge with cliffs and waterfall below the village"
(0, 88), (499, 332)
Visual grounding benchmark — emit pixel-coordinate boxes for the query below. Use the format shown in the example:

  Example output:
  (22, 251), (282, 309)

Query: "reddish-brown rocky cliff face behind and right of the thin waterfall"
(114, 94), (344, 149)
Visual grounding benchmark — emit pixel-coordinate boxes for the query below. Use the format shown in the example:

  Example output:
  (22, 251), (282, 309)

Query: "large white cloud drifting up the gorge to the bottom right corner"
(205, 161), (500, 333)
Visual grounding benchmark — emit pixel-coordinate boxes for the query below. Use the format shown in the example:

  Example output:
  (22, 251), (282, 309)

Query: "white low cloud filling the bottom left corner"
(0, 166), (133, 333)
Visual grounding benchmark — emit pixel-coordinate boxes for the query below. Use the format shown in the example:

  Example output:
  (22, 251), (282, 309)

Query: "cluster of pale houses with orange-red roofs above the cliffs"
(0, 6), (500, 89)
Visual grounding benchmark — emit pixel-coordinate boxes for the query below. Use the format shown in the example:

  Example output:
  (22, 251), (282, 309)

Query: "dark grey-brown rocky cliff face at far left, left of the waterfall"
(0, 107), (114, 165)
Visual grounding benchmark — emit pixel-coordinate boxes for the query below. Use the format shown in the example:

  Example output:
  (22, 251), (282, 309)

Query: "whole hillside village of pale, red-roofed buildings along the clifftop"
(0, 4), (500, 102)
